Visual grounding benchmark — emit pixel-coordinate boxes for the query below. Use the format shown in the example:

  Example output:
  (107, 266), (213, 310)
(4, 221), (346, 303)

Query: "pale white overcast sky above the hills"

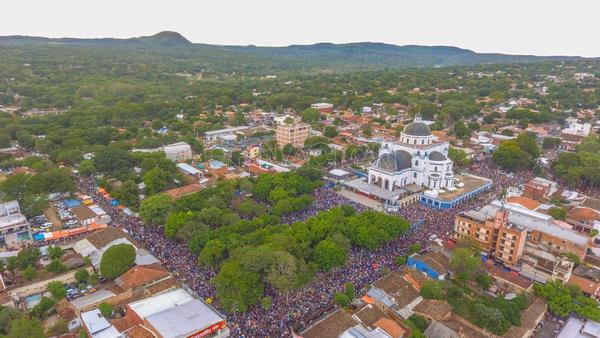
(0, 0), (600, 57)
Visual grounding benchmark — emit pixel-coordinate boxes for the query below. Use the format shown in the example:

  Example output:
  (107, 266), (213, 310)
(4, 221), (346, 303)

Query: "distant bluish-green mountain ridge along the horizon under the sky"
(0, 31), (597, 68)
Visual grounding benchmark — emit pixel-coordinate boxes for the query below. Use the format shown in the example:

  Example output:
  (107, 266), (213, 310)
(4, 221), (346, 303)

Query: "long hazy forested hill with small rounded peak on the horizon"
(0, 31), (583, 71)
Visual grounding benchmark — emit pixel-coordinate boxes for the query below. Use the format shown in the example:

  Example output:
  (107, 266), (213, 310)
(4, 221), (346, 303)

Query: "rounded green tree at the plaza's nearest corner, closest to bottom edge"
(213, 261), (264, 312)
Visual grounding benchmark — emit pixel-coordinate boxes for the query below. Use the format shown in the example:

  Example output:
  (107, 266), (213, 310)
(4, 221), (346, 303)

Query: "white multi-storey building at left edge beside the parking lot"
(0, 201), (32, 249)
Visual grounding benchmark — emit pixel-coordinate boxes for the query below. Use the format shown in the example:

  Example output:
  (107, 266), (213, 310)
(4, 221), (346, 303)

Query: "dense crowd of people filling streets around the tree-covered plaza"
(80, 156), (531, 337)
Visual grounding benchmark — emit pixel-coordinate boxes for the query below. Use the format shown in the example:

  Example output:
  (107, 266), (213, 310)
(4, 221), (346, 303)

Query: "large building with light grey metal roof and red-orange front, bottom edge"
(126, 289), (229, 338)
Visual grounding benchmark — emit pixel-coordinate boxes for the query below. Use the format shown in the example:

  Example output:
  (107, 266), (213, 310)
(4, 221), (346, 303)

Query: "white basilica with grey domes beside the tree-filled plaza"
(368, 116), (454, 191)
